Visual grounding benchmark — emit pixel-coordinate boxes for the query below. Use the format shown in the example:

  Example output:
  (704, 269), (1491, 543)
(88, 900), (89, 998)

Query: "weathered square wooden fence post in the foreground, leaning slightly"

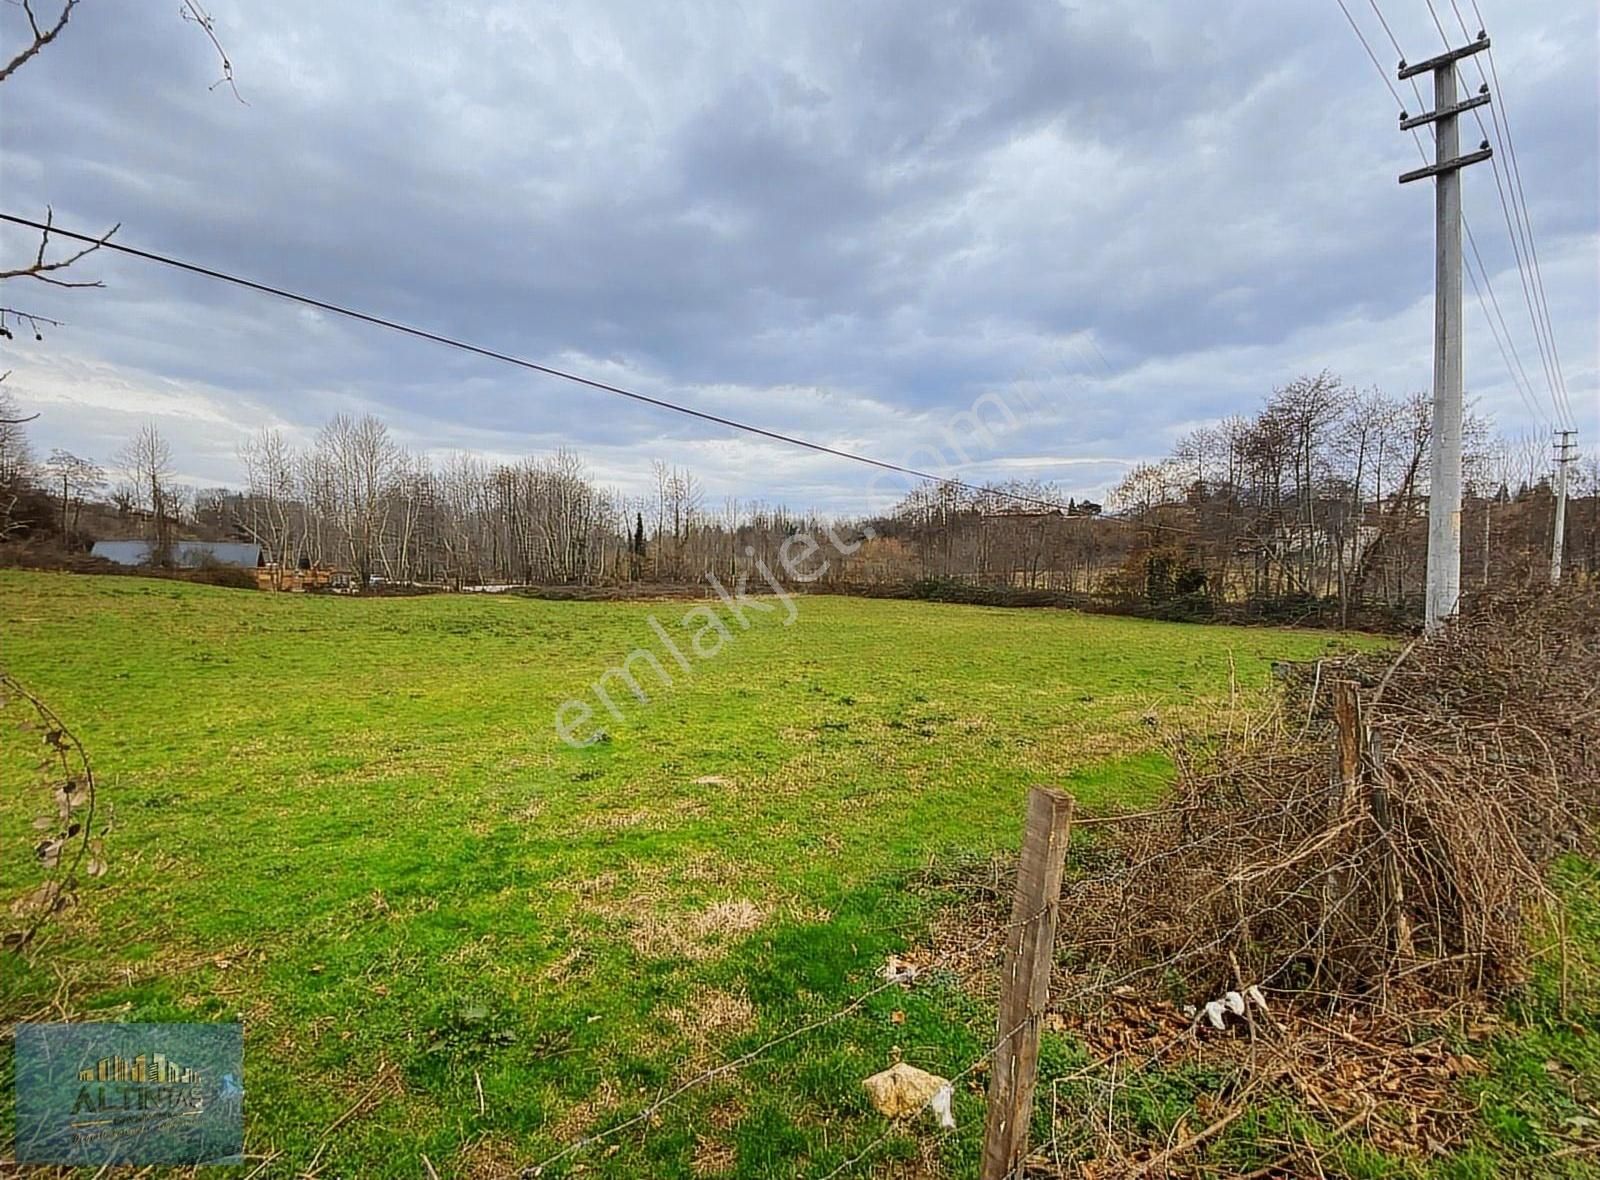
(982, 787), (1072, 1180)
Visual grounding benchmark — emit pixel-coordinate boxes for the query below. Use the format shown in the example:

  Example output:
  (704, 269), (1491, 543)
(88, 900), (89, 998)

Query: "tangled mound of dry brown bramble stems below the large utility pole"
(1062, 578), (1600, 1007)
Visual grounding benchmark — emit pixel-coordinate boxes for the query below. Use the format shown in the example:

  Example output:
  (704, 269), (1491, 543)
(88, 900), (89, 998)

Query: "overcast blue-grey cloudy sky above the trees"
(0, 0), (1600, 512)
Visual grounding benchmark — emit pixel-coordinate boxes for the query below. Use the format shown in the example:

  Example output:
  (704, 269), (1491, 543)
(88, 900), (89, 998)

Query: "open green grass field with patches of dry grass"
(0, 572), (1574, 1177)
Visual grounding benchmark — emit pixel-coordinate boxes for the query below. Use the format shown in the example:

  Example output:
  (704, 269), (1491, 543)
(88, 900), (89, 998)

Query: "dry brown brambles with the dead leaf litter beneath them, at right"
(934, 588), (1600, 1177)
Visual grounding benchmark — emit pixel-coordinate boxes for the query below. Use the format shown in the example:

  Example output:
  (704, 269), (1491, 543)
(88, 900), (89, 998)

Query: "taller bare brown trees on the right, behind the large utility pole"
(1112, 373), (1597, 614)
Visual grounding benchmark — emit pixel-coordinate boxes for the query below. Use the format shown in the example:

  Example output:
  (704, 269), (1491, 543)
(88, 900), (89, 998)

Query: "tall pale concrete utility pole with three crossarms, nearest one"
(1400, 30), (1493, 630)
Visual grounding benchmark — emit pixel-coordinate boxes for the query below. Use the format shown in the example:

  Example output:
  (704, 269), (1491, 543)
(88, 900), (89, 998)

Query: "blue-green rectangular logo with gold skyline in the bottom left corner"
(16, 1023), (245, 1164)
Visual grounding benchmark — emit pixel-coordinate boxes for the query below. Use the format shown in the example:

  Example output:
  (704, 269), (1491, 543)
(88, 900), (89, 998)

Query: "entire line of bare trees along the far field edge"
(0, 373), (1600, 620)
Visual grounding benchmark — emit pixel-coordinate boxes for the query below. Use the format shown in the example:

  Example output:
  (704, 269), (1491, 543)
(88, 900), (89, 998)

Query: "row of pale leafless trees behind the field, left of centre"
(208, 414), (844, 587)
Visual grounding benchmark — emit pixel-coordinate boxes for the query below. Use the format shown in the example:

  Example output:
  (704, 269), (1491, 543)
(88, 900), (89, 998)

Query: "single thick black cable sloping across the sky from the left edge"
(0, 213), (1164, 524)
